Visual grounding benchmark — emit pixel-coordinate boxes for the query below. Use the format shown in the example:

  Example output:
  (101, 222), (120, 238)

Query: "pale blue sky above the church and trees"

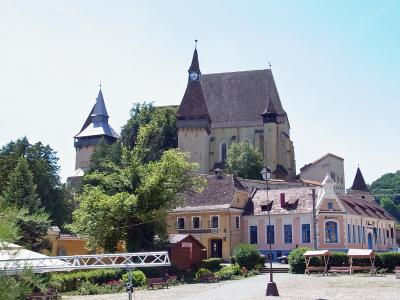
(0, 0), (400, 186)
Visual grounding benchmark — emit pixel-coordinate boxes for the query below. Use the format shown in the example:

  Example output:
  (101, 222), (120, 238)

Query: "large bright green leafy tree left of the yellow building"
(71, 149), (204, 251)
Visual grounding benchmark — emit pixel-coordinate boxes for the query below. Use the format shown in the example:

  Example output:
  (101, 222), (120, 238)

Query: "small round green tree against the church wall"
(226, 143), (263, 179)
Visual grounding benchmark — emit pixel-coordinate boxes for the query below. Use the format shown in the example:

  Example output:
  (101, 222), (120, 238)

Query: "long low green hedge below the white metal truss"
(50, 269), (125, 292)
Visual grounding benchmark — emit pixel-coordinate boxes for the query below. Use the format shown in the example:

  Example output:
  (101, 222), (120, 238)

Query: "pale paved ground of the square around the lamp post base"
(63, 274), (400, 300)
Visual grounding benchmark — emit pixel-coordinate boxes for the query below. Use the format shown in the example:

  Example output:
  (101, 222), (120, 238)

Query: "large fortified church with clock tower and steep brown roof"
(176, 45), (296, 179)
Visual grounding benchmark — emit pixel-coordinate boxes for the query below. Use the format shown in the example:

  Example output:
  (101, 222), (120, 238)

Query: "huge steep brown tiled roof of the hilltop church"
(200, 70), (286, 127)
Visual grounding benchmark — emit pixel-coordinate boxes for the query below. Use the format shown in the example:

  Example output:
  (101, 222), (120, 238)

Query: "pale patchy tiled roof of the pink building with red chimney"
(249, 187), (319, 215)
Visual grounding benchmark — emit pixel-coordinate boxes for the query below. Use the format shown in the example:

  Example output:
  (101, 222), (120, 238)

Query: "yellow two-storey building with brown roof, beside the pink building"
(168, 172), (249, 260)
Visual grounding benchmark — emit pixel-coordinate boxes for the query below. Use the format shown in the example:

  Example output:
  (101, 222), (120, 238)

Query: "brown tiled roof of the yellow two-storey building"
(176, 175), (246, 211)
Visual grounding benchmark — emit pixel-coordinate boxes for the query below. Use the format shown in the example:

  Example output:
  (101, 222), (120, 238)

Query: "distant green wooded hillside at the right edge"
(370, 171), (400, 221)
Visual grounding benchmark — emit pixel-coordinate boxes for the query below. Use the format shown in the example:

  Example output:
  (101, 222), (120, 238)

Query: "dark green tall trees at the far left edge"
(0, 137), (68, 226)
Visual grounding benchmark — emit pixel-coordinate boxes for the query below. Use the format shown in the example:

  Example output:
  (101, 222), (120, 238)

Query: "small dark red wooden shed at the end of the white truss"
(168, 234), (207, 270)
